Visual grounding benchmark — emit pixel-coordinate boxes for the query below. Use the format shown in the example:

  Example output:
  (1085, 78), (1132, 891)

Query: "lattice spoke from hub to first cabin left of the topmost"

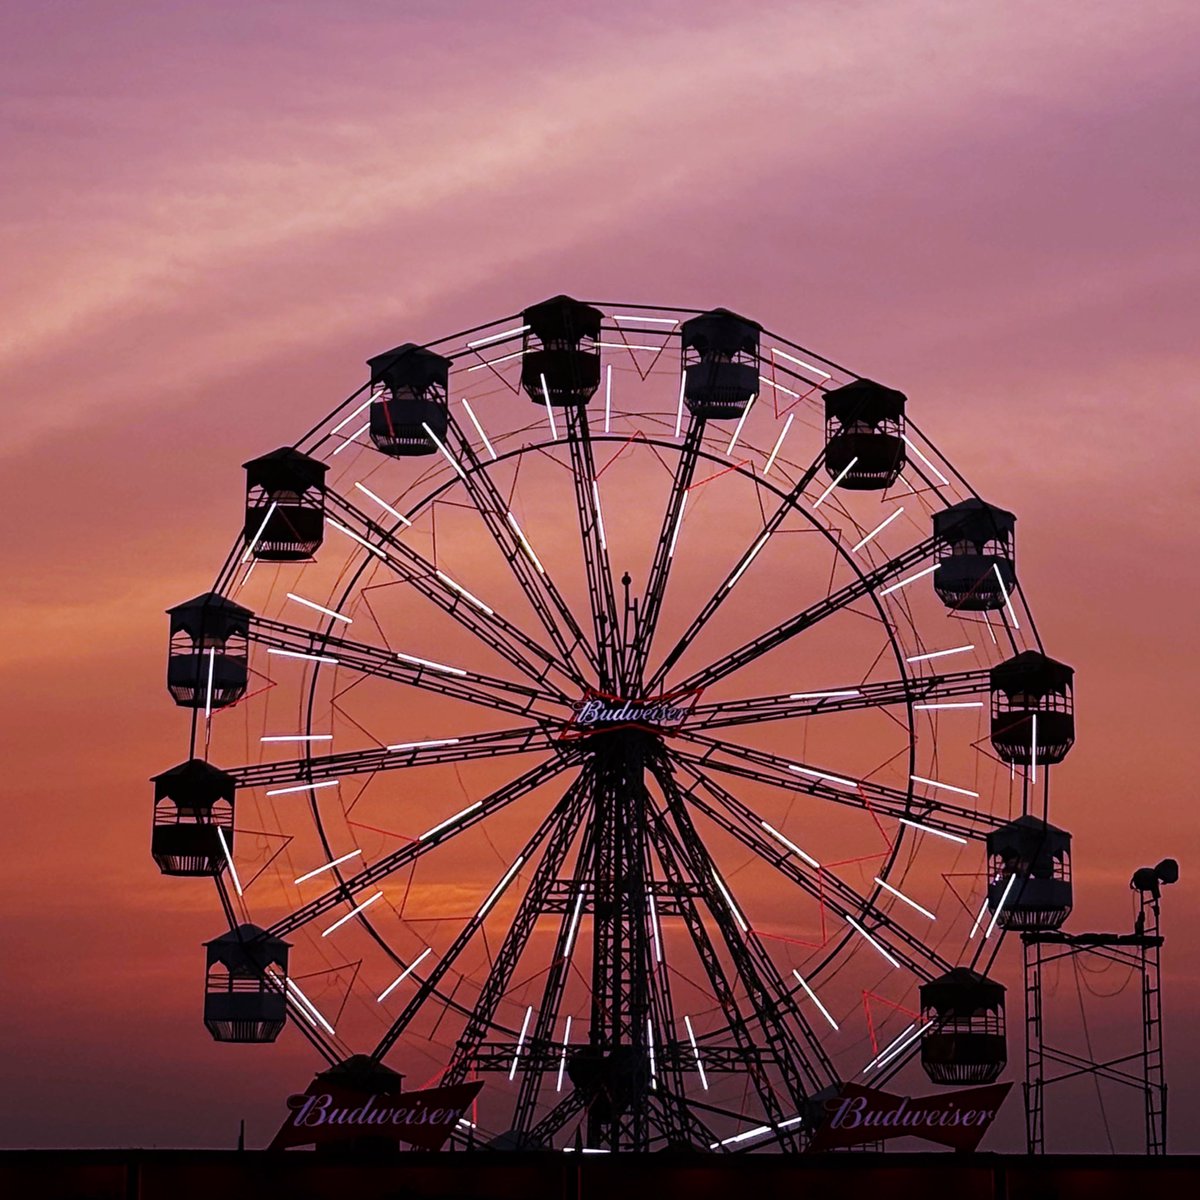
(448, 418), (598, 683)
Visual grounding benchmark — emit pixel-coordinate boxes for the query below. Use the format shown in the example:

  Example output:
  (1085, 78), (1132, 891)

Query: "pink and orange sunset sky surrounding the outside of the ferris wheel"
(0, 0), (1200, 1152)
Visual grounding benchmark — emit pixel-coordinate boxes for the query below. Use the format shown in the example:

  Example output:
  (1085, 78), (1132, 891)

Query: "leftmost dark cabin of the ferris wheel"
(150, 758), (236, 876)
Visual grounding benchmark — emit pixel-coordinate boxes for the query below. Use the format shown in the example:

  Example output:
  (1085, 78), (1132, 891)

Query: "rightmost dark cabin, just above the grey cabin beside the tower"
(991, 650), (1075, 766)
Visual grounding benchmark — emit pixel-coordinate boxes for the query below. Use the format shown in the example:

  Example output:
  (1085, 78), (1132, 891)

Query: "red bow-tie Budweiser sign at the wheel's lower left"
(268, 1079), (484, 1150)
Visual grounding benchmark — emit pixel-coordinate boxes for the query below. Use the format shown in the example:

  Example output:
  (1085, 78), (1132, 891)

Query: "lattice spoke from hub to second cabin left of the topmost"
(325, 488), (575, 700)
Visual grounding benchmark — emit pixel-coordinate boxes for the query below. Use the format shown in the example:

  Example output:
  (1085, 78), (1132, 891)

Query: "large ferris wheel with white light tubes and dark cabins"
(152, 296), (1074, 1152)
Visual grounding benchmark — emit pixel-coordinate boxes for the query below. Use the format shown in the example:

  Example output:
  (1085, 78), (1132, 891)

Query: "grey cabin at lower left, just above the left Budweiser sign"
(204, 925), (290, 1042)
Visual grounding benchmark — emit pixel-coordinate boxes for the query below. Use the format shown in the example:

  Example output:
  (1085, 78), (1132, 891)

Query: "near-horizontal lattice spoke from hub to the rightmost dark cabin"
(690, 668), (991, 730)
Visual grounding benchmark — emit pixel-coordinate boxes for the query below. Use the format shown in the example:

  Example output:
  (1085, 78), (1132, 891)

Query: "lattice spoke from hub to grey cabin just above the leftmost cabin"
(247, 617), (566, 719)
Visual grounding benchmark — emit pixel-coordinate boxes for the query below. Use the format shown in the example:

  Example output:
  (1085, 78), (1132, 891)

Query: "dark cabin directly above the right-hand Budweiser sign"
(920, 967), (1008, 1086)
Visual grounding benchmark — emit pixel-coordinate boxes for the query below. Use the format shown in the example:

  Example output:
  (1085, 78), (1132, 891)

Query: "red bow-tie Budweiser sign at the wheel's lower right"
(809, 1084), (1013, 1151)
